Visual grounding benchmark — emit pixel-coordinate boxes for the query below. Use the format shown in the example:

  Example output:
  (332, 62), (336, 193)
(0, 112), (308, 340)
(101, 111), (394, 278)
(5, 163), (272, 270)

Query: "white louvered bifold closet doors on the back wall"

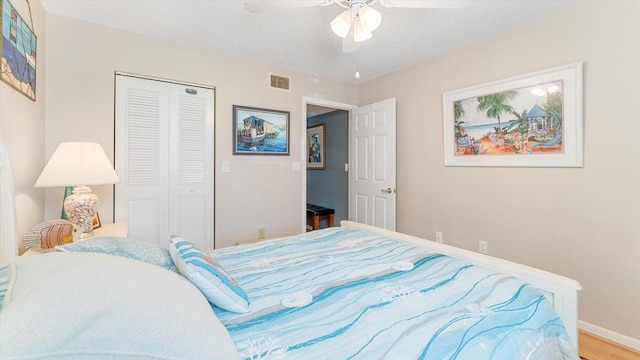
(114, 73), (215, 250)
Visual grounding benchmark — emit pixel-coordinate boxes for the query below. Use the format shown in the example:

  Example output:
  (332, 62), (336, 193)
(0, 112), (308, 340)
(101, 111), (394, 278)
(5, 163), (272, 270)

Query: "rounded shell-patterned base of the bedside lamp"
(64, 185), (98, 239)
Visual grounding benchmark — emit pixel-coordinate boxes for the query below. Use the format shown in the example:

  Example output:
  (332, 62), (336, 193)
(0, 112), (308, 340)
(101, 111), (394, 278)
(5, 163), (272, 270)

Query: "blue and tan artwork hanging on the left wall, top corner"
(0, 0), (37, 101)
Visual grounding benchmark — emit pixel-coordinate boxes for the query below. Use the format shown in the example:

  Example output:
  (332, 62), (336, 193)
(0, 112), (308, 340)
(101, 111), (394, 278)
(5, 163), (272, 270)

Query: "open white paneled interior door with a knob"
(349, 98), (396, 231)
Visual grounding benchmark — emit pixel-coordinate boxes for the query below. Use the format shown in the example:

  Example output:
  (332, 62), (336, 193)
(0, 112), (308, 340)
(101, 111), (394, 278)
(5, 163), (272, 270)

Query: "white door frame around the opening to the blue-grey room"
(300, 96), (358, 233)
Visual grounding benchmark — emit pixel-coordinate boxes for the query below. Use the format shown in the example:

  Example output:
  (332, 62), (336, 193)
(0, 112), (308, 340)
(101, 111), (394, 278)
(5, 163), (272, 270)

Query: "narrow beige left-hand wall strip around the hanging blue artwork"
(0, 1), (46, 258)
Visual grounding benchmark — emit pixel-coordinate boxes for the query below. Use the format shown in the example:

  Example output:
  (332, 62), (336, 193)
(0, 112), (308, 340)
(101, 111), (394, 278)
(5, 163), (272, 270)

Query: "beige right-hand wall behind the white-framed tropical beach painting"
(359, 1), (640, 339)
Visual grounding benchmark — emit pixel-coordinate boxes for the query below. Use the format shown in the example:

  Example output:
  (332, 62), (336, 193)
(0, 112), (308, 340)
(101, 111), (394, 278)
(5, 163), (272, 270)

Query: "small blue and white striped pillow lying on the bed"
(169, 235), (249, 313)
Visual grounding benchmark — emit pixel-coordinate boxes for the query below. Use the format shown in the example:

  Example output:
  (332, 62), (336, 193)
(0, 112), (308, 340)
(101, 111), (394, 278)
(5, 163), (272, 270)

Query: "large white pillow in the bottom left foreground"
(0, 252), (239, 360)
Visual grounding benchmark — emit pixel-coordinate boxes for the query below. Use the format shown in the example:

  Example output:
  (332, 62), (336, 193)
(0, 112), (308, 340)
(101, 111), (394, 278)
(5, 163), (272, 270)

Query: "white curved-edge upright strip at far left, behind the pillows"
(0, 133), (18, 266)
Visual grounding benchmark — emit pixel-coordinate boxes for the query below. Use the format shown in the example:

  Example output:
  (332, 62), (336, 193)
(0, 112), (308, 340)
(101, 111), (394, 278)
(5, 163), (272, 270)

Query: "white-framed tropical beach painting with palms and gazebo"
(443, 63), (583, 167)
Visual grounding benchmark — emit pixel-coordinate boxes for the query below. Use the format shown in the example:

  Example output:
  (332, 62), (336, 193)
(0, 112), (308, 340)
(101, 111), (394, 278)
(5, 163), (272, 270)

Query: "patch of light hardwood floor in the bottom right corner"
(578, 330), (640, 360)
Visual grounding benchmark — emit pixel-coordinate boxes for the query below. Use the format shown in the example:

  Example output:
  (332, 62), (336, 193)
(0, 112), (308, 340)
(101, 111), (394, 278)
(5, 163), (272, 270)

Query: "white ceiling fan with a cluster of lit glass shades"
(244, 0), (469, 53)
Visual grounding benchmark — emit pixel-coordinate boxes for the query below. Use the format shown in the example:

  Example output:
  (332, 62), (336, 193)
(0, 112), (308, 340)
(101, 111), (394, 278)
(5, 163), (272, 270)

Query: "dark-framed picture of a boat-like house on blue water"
(233, 105), (289, 155)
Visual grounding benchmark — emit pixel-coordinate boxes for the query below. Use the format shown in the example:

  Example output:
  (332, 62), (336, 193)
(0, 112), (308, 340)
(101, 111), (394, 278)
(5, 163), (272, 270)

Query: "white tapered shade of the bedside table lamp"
(35, 142), (120, 187)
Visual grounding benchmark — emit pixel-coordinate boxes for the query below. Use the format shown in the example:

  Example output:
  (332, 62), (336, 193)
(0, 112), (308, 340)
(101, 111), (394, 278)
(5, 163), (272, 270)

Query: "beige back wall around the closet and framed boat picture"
(46, 14), (357, 247)
